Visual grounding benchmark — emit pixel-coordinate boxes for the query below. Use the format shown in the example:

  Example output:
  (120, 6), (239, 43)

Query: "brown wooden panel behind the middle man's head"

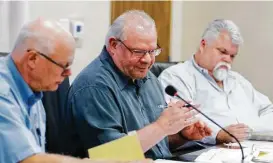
(111, 1), (171, 62)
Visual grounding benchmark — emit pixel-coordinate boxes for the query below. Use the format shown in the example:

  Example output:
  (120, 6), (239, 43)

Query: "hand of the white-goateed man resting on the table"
(216, 123), (250, 143)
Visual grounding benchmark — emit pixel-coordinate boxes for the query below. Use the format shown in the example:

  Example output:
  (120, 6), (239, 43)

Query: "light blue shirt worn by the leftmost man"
(0, 56), (45, 163)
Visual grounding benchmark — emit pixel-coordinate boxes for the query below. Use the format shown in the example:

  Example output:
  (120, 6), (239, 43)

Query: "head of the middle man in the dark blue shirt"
(105, 10), (157, 80)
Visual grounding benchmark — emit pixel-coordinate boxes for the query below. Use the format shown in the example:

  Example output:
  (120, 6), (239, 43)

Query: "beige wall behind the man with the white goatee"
(182, 2), (273, 100)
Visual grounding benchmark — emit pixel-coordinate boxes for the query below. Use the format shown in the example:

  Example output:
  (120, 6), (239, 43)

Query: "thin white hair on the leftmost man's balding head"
(14, 20), (75, 55)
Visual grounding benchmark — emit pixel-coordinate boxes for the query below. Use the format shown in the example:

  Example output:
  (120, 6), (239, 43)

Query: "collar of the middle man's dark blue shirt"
(99, 46), (151, 90)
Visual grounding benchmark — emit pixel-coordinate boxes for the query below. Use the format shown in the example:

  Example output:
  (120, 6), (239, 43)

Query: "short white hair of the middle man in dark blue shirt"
(105, 10), (156, 47)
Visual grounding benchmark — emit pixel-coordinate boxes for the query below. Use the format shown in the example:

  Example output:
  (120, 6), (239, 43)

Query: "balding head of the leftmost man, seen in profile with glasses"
(11, 18), (75, 91)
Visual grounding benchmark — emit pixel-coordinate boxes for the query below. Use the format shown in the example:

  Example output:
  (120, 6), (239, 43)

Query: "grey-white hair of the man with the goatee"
(202, 19), (243, 45)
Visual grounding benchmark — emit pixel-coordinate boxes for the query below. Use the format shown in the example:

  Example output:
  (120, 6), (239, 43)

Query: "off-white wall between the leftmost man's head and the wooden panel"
(29, 1), (110, 81)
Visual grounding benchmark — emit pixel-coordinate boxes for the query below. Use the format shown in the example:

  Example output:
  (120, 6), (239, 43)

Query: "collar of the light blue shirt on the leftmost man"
(7, 55), (43, 107)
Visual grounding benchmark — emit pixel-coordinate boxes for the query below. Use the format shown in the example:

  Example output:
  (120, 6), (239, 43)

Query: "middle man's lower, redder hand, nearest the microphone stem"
(180, 121), (212, 140)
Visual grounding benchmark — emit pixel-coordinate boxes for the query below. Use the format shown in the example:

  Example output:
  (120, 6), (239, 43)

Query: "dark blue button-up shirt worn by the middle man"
(62, 48), (171, 159)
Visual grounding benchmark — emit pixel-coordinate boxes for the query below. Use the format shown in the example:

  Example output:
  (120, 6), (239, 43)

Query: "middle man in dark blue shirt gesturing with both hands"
(62, 11), (210, 159)
